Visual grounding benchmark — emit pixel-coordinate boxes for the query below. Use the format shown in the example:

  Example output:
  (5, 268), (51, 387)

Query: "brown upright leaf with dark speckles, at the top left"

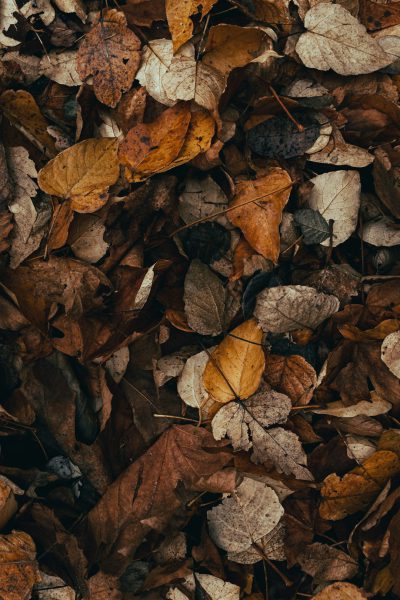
(77, 9), (140, 107)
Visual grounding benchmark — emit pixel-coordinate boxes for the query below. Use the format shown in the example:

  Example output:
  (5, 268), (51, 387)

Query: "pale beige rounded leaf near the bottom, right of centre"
(207, 477), (284, 560)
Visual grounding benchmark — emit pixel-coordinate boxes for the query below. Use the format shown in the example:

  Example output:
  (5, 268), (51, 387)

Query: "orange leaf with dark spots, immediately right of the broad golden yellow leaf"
(119, 103), (191, 181)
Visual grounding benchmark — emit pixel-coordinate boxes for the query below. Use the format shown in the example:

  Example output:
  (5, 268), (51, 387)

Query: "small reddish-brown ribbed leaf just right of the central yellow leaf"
(264, 354), (317, 406)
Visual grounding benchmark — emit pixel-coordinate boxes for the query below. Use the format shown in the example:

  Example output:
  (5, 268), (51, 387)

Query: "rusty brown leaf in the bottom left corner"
(0, 531), (40, 600)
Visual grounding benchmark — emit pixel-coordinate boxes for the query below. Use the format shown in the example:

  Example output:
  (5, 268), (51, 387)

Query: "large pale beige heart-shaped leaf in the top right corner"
(296, 3), (392, 75)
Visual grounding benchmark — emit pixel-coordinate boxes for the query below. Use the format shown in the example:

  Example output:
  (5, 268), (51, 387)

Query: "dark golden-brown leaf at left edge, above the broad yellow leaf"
(0, 90), (56, 156)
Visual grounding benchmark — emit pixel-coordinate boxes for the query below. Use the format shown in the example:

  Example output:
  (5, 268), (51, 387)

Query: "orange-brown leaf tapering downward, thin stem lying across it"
(228, 167), (292, 263)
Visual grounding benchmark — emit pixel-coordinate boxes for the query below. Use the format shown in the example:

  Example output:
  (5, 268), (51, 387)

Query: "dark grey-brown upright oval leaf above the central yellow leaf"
(183, 260), (230, 335)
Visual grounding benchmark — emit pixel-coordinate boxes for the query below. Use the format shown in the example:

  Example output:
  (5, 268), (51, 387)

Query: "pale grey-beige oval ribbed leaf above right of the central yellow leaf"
(254, 285), (339, 333)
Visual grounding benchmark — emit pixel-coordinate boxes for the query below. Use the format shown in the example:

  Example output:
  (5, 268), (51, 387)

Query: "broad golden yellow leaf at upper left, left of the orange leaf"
(38, 138), (119, 212)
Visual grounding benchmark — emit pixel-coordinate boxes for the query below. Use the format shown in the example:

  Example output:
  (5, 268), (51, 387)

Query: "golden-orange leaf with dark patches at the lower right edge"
(319, 450), (400, 521)
